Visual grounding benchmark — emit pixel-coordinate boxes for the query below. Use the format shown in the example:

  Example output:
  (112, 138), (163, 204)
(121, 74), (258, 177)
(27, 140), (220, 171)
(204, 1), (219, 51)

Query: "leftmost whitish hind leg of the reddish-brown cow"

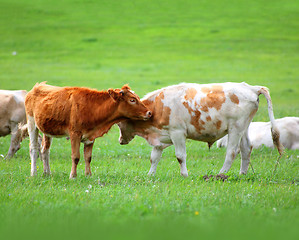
(28, 116), (39, 176)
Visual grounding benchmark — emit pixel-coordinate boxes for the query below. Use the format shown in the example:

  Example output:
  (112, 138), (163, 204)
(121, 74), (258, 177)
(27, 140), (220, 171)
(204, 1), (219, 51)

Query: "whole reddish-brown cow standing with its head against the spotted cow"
(25, 83), (151, 178)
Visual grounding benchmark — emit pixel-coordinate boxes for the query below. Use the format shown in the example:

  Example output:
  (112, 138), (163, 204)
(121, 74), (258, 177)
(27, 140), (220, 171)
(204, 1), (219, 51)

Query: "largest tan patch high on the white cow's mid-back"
(200, 85), (226, 112)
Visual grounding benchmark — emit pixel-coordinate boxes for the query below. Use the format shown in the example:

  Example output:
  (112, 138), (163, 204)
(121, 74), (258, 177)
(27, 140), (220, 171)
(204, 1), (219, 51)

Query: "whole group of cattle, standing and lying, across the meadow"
(0, 83), (299, 178)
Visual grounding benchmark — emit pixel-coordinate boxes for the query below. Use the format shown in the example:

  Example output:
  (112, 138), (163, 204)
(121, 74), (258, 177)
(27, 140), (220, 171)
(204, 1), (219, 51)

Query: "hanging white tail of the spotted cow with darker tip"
(258, 87), (284, 155)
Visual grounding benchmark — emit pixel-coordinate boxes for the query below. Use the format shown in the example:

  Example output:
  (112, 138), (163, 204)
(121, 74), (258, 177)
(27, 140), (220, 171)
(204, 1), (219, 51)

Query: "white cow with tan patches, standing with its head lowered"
(118, 83), (283, 177)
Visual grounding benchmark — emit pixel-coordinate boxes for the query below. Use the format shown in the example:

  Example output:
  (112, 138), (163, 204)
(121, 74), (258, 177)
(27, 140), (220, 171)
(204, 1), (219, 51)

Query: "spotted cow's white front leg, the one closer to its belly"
(171, 132), (188, 177)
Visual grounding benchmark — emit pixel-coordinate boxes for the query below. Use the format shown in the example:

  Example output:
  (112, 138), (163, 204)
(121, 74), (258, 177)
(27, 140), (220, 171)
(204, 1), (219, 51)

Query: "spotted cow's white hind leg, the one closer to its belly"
(219, 128), (244, 173)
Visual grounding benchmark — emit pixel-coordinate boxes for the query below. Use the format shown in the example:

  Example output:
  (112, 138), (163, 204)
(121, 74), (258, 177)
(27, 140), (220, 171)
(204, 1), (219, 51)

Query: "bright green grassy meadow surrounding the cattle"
(0, 0), (299, 239)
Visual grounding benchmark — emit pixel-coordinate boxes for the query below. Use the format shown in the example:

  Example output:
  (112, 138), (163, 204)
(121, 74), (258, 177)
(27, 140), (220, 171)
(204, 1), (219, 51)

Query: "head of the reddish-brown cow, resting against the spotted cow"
(108, 85), (152, 120)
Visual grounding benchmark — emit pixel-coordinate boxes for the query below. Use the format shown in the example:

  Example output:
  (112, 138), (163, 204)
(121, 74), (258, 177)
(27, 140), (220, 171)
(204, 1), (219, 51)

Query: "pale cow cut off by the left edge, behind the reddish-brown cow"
(0, 90), (27, 159)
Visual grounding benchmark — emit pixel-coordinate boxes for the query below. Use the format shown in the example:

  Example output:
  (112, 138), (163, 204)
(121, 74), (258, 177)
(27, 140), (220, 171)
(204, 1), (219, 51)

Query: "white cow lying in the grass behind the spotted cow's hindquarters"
(217, 117), (299, 149)
